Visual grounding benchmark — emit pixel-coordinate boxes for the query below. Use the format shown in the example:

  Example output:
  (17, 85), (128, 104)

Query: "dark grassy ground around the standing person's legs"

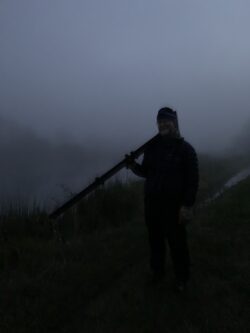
(0, 172), (250, 333)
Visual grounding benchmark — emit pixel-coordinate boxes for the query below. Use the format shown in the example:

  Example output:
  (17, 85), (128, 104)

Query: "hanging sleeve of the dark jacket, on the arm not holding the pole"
(183, 144), (199, 207)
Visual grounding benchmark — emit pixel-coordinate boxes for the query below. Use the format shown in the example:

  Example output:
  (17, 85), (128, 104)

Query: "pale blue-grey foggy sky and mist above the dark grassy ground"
(0, 0), (250, 208)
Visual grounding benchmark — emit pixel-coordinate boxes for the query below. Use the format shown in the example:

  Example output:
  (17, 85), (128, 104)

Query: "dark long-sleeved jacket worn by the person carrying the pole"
(133, 136), (199, 207)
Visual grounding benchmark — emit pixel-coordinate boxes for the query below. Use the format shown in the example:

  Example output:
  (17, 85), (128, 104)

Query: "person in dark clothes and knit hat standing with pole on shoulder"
(127, 107), (199, 291)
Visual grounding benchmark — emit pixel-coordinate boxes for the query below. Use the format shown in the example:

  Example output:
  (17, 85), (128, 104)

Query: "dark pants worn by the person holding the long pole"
(144, 198), (190, 282)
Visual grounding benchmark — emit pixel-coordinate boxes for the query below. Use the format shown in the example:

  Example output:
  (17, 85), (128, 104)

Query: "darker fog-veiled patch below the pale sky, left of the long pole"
(0, 114), (123, 208)
